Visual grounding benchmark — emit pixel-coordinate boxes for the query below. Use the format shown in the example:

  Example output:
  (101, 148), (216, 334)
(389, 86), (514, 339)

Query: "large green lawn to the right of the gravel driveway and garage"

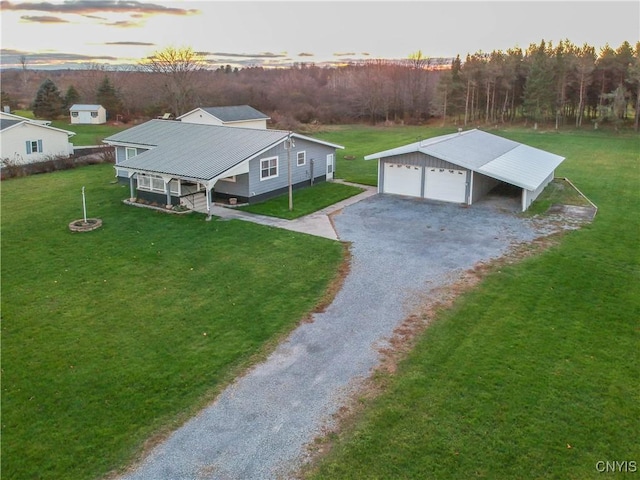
(308, 130), (640, 479)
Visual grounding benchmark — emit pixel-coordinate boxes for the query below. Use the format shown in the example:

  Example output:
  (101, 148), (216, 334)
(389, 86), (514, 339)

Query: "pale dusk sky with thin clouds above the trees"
(0, 0), (640, 69)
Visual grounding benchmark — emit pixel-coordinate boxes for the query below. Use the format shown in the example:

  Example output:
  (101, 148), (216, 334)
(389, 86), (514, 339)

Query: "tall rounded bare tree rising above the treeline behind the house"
(139, 47), (205, 116)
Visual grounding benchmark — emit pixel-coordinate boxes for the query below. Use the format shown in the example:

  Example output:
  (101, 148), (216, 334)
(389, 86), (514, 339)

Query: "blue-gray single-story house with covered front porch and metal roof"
(104, 119), (343, 212)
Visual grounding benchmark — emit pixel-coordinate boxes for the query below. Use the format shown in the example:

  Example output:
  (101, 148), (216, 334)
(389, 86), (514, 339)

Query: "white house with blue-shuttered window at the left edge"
(0, 113), (75, 166)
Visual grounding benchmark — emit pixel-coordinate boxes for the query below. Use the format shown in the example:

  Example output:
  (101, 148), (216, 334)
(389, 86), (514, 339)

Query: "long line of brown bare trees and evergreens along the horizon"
(2, 40), (640, 130)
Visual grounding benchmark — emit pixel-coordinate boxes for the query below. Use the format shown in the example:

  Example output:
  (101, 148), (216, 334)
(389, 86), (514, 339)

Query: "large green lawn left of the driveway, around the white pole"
(1, 165), (342, 480)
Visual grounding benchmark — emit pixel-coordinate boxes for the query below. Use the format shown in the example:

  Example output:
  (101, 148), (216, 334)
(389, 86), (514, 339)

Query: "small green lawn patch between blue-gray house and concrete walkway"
(239, 182), (364, 220)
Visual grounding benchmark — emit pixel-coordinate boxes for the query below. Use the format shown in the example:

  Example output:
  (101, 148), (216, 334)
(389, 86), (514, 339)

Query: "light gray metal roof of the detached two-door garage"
(364, 129), (564, 190)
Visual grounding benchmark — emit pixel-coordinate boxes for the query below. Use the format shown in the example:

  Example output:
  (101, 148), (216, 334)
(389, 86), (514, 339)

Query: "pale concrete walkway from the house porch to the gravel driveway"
(205, 180), (377, 240)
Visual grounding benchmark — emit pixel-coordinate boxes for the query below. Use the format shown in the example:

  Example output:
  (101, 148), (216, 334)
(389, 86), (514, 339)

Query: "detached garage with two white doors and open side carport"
(364, 129), (564, 211)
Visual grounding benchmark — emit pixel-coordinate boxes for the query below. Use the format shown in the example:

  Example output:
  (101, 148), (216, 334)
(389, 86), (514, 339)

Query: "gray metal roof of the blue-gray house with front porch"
(104, 120), (342, 180)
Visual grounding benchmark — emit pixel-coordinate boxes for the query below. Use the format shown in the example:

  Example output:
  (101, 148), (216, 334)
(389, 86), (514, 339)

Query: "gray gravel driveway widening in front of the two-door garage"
(121, 195), (556, 480)
